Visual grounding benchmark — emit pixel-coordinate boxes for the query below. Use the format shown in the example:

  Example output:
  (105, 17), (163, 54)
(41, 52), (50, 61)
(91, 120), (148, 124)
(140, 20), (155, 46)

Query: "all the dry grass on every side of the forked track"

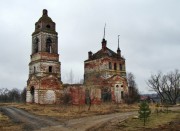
(0, 103), (180, 131)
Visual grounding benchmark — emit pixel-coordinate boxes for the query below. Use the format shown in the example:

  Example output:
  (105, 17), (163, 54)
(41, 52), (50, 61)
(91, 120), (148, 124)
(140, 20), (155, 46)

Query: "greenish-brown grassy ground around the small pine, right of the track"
(96, 108), (180, 131)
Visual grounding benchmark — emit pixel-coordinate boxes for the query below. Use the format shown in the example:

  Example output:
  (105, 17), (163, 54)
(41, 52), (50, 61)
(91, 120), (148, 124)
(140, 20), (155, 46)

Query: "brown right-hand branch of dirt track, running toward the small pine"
(41, 112), (136, 131)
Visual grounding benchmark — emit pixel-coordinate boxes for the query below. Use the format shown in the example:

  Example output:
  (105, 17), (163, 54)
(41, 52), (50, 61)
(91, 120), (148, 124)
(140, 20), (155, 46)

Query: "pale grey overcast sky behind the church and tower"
(0, 0), (180, 93)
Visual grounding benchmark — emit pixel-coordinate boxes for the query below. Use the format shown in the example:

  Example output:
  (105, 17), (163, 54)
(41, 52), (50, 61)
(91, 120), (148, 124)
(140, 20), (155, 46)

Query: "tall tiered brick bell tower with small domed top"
(26, 9), (62, 104)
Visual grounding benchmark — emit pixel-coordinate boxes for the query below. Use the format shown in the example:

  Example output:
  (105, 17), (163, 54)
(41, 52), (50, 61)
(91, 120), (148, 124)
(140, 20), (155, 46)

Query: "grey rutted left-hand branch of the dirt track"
(0, 107), (61, 131)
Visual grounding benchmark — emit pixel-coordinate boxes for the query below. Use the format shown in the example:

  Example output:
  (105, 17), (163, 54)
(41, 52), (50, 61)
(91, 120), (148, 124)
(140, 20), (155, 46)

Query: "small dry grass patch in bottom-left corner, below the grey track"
(0, 112), (22, 131)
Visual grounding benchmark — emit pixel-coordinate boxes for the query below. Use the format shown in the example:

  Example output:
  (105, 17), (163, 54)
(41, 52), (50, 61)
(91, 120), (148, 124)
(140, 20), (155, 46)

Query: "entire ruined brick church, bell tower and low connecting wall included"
(26, 9), (128, 104)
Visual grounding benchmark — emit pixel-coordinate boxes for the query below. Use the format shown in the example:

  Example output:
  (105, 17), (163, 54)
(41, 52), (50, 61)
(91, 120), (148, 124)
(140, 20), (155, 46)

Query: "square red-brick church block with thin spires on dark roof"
(84, 38), (128, 103)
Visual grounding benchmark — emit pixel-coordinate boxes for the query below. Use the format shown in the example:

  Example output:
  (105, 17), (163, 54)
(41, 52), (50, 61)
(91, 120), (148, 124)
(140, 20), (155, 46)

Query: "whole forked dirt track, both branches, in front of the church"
(0, 107), (135, 131)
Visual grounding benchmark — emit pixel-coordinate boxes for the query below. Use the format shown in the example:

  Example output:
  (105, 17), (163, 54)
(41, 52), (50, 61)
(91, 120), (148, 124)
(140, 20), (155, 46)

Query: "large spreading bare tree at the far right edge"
(147, 70), (180, 104)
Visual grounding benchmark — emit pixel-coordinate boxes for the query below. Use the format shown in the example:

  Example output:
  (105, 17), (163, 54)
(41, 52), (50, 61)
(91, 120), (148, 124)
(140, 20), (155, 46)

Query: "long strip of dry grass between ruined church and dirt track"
(1, 103), (138, 119)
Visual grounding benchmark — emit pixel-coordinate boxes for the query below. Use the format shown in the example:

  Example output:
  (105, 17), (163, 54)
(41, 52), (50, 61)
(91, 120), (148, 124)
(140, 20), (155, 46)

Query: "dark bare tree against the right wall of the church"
(125, 72), (140, 104)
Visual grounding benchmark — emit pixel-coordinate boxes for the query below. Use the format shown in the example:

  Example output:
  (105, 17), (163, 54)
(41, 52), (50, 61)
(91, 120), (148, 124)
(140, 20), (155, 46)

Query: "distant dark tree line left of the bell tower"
(0, 88), (26, 103)
